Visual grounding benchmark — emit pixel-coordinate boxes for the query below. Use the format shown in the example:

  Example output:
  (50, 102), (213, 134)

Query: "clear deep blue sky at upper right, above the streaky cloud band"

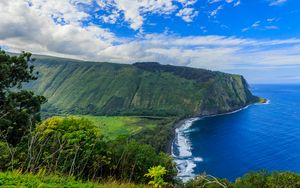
(90, 0), (300, 39)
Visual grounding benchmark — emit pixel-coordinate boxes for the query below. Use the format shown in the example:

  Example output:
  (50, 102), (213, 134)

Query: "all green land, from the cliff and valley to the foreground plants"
(0, 51), (300, 187)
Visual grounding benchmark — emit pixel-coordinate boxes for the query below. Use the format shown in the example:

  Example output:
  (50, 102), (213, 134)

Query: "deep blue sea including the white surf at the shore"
(172, 85), (300, 181)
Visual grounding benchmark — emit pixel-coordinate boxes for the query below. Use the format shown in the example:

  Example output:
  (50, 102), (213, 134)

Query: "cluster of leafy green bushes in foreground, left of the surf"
(0, 116), (176, 182)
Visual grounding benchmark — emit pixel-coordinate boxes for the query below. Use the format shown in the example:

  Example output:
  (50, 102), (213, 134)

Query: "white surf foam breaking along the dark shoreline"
(172, 118), (203, 182)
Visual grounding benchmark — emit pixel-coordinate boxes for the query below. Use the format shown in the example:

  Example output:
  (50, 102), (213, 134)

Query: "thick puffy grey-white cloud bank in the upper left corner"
(0, 0), (114, 58)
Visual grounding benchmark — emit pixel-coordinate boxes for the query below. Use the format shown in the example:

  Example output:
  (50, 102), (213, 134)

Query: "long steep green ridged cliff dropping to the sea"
(27, 56), (257, 117)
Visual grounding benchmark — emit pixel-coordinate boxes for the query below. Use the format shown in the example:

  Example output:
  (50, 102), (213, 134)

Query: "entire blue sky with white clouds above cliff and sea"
(0, 0), (300, 83)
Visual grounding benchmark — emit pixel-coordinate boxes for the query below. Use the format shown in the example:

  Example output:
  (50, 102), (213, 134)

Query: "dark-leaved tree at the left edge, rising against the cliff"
(0, 50), (46, 146)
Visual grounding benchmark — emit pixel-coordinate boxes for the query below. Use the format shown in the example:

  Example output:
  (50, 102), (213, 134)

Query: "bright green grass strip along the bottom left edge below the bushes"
(0, 171), (147, 188)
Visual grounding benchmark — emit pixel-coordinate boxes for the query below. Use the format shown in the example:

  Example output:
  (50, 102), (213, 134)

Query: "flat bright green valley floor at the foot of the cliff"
(78, 115), (179, 152)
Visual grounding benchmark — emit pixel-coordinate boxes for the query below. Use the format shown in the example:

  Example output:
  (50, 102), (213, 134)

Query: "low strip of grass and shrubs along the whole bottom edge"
(0, 169), (300, 188)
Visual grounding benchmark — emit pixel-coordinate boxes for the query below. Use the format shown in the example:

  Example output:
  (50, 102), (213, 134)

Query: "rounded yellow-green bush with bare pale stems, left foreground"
(26, 117), (109, 177)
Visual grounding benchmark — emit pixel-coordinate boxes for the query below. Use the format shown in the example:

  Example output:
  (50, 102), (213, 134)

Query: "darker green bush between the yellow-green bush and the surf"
(110, 140), (176, 183)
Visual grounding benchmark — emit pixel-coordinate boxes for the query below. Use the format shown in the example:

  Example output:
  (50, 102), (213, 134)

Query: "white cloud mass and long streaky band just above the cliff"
(0, 0), (300, 74)
